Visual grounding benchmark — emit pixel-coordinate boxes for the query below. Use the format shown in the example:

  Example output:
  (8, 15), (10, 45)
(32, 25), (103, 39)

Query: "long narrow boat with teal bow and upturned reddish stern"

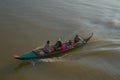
(13, 33), (93, 60)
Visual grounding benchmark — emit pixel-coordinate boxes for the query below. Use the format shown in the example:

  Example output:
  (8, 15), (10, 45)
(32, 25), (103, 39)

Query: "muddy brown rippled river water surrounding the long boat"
(0, 0), (120, 80)
